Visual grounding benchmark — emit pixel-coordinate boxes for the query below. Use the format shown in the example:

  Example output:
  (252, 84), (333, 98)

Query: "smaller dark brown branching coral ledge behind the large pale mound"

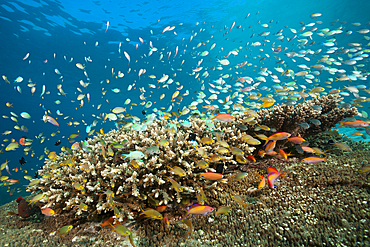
(256, 95), (358, 137)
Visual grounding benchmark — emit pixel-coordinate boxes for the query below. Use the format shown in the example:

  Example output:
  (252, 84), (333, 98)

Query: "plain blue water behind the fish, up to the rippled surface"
(0, 0), (370, 204)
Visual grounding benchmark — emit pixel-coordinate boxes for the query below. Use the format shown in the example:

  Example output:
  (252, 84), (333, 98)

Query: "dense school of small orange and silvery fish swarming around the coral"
(0, 13), (370, 243)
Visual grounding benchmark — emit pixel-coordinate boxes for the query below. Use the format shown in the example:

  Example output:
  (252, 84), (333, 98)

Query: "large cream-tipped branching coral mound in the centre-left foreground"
(28, 116), (254, 220)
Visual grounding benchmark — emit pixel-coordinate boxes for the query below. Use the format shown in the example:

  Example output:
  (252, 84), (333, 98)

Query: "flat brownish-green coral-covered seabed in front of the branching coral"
(0, 151), (370, 247)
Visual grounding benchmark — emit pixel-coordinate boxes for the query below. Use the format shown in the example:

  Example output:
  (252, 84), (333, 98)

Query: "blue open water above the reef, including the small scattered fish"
(0, 0), (370, 246)
